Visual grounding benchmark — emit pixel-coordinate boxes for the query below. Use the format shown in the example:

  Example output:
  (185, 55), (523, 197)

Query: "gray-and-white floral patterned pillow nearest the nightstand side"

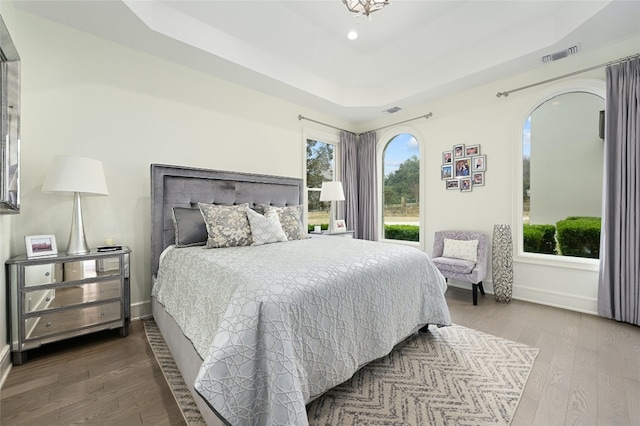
(198, 203), (252, 248)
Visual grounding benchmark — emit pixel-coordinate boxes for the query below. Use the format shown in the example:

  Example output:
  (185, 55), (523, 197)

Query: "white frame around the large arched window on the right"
(513, 79), (607, 271)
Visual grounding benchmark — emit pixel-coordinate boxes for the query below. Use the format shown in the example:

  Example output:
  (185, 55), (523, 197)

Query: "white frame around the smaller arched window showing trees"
(376, 126), (426, 250)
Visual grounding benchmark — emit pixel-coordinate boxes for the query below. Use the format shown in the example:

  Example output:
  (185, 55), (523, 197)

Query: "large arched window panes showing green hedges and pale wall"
(519, 85), (605, 259)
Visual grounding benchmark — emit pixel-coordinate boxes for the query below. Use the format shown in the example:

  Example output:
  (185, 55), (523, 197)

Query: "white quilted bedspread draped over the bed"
(153, 237), (451, 426)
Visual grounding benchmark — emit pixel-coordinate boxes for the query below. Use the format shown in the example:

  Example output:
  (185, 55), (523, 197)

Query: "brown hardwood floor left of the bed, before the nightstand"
(0, 321), (186, 426)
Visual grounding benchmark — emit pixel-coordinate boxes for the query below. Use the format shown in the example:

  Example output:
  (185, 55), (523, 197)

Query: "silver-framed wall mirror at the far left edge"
(0, 17), (20, 214)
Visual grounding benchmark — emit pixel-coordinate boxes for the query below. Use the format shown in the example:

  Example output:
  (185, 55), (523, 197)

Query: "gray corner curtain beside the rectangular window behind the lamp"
(339, 130), (359, 238)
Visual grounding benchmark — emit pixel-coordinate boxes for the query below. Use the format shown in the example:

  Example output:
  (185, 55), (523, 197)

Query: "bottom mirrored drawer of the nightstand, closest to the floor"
(24, 302), (122, 340)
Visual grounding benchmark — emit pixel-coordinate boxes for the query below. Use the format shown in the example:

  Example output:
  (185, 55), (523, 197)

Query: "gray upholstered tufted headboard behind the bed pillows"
(151, 164), (304, 276)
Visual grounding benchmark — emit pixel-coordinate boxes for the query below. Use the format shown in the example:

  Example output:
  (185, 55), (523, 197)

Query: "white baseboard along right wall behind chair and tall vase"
(448, 280), (598, 315)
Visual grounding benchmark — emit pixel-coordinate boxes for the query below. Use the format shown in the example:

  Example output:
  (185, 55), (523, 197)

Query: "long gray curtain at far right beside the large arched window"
(598, 58), (640, 325)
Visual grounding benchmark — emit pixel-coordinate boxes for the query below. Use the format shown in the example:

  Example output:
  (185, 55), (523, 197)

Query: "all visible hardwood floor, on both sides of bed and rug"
(0, 288), (640, 426)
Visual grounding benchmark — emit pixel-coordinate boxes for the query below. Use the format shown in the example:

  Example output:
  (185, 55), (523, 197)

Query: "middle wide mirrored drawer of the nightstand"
(23, 278), (122, 313)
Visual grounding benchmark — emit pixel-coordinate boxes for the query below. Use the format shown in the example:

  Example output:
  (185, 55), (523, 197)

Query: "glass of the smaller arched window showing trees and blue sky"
(381, 133), (420, 242)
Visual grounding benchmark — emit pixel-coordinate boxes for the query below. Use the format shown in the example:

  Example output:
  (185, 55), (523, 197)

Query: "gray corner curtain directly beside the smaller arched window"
(356, 132), (378, 241)
